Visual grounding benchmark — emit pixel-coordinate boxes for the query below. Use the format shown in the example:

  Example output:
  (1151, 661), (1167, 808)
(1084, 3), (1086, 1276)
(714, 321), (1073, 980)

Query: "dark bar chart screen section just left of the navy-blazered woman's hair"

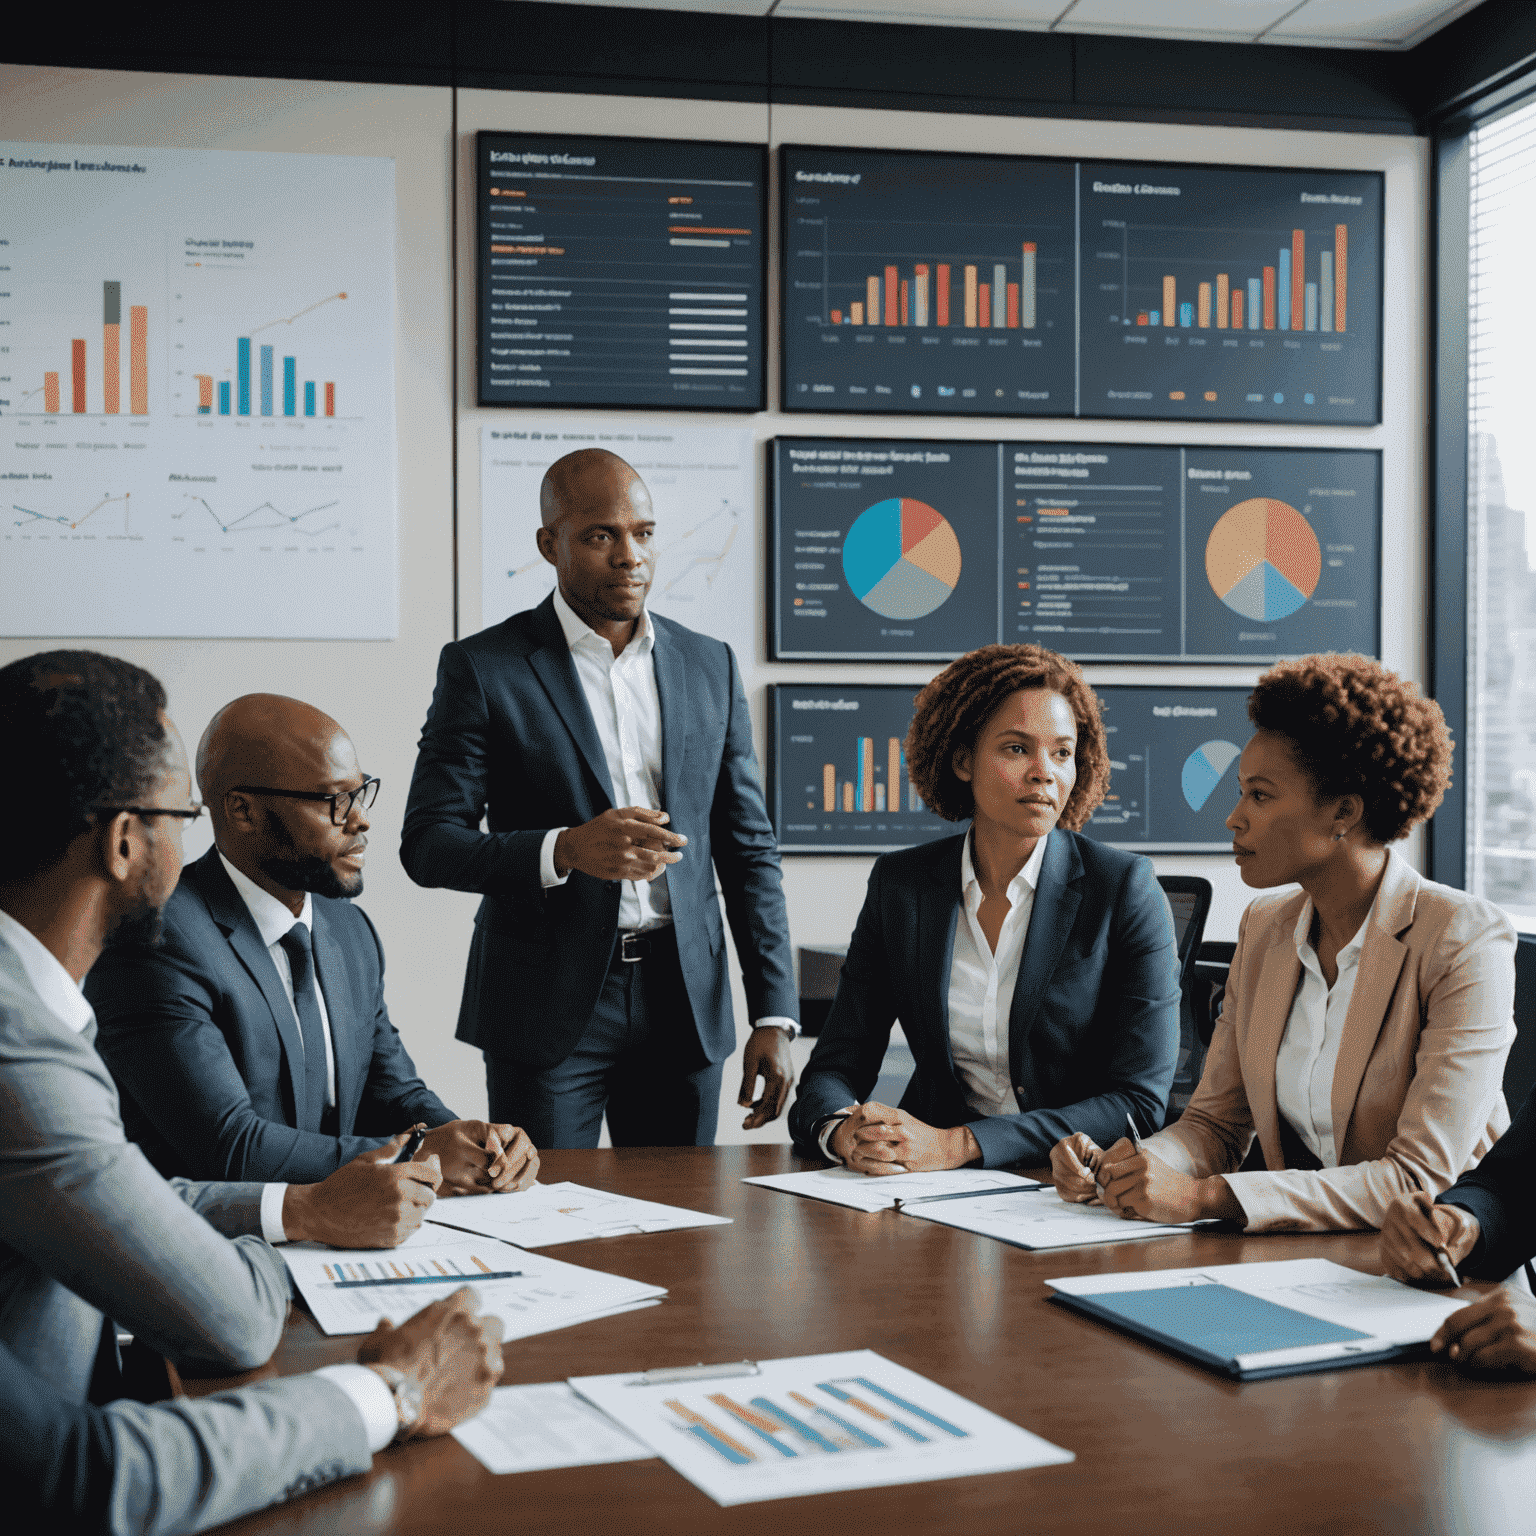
(768, 684), (962, 854)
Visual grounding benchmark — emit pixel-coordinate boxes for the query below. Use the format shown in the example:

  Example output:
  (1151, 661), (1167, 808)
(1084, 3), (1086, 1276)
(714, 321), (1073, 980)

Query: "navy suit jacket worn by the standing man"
(401, 593), (800, 1071)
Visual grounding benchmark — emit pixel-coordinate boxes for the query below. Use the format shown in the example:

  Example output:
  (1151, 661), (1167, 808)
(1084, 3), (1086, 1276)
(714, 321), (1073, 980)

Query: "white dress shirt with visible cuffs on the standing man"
(539, 587), (799, 1040)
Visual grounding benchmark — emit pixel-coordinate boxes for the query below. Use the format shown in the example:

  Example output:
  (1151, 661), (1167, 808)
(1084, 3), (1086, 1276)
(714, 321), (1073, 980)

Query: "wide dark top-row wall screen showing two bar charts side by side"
(780, 144), (1384, 425)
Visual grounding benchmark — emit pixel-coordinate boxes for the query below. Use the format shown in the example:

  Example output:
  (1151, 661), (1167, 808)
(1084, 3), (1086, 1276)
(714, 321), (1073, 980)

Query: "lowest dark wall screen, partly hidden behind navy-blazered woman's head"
(768, 684), (1253, 854)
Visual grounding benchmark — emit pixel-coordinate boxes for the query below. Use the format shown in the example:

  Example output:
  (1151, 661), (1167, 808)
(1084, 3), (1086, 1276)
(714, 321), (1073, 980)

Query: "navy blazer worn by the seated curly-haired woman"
(790, 828), (1180, 1167)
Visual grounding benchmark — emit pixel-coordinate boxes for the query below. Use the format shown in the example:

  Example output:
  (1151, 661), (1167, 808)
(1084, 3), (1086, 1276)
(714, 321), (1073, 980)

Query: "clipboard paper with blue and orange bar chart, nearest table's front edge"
(571, 1350), (1075, 1508)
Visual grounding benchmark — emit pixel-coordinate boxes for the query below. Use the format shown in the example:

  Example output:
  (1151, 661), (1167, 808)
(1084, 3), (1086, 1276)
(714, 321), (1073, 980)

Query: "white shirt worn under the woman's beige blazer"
(1275, 902), (1375, 1167)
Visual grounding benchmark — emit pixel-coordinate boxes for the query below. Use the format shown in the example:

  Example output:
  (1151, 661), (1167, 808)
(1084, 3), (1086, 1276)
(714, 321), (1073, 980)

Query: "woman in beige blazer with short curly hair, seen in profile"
(1069, 656), (1514, 1232)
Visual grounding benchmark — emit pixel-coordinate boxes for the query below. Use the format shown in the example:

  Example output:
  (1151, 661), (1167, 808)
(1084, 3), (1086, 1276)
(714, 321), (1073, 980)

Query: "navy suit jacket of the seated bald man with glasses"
(86, 848), (455, 1184)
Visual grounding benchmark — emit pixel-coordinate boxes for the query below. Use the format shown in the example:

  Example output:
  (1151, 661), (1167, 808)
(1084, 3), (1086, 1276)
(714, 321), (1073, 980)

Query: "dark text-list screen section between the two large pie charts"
(1003, 442), (1184, 660)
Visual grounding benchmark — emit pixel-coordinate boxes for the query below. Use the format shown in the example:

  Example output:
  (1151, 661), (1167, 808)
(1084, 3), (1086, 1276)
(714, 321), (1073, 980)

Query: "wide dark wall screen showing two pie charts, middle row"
(770, 438), (1381, 665)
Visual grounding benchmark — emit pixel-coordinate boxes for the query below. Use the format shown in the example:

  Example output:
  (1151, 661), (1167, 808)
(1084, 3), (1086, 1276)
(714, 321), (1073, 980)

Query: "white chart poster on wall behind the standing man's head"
(481, 415), (759, 660)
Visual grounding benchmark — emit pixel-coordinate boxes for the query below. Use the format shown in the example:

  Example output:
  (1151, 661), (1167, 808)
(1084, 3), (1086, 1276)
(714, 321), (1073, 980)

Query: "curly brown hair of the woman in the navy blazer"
(906, 645), (1109, 833)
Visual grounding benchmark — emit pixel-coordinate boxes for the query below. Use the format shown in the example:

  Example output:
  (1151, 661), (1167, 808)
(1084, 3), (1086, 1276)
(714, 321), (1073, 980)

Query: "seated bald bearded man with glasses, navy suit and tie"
(88, 693), (539, 1212)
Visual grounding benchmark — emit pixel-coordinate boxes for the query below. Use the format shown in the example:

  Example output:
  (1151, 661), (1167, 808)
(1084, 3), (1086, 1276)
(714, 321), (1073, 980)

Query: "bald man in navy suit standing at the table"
(401, 449), (797, 1147)
